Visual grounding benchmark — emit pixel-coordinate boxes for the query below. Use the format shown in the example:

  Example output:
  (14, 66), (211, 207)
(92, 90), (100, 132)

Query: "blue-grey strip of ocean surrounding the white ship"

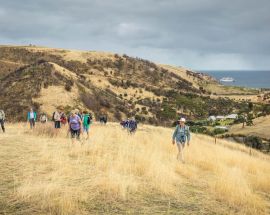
(200, 71), (270, 88)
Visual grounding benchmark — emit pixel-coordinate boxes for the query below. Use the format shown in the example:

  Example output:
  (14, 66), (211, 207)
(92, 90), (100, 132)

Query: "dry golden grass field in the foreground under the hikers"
(0, 124), (270, 214)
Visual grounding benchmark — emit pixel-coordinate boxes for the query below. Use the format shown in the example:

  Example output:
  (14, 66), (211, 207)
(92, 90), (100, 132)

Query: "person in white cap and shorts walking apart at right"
(172, 118), (190, 163)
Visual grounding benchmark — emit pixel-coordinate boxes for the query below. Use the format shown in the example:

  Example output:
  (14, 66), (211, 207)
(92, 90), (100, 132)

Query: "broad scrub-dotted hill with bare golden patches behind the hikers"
(0, 46), (258, 125)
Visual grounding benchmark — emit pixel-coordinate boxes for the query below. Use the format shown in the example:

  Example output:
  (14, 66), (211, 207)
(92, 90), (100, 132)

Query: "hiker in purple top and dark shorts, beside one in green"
(69, 110), (82, 143)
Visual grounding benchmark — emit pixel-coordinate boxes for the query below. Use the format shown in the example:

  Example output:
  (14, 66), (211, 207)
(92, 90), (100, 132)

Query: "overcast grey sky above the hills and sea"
(0, 0), (270, 70)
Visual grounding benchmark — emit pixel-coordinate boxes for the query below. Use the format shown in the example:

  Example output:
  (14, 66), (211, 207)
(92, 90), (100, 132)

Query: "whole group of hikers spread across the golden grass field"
(0, 108), (191, 163)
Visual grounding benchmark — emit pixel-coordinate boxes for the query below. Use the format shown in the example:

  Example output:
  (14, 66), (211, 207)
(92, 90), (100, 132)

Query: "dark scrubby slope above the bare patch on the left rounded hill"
(0, 62), (75, 120)
